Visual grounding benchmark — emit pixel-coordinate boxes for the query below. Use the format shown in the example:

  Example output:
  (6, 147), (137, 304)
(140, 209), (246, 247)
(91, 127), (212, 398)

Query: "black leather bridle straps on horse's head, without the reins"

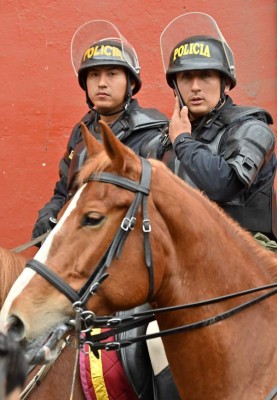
(26, 158), (154, 307)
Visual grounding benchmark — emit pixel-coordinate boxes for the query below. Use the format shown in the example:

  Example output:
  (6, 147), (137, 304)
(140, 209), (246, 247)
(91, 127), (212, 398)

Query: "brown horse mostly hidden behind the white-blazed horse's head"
(0, 247), (85, 400)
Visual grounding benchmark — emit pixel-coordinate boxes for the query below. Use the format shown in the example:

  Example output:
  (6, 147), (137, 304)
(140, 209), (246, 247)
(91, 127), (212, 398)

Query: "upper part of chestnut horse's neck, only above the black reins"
(149, 166), (276, 305)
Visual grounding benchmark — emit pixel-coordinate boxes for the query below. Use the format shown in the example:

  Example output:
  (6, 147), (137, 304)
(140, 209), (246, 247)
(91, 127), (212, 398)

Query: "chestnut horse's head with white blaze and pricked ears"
(1, 121), (166, 362)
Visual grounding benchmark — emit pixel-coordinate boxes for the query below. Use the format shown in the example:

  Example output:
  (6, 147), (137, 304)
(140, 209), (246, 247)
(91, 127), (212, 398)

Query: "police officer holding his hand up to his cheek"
(159, 13), (277, 244)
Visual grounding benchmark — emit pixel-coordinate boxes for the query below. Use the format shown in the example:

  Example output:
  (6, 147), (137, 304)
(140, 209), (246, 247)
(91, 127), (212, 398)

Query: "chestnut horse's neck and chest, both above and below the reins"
(150, 173), (277, 400)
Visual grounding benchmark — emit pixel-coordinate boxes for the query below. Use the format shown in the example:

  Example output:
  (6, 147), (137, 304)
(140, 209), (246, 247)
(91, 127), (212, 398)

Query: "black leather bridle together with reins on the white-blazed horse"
(26, 158), (277, 353)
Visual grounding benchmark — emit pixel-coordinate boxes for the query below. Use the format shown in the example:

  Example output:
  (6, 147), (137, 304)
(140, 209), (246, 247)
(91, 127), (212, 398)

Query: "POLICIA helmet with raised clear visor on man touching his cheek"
(160, 12), (236, 89)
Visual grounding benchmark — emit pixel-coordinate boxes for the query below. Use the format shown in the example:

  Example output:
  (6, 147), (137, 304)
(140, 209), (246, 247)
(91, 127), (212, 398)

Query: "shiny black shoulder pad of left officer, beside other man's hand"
(128, 108), (168, 131)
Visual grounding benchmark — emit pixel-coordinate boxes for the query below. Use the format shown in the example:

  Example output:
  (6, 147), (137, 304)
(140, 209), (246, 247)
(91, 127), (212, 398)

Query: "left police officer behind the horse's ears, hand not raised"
(32, 21), (168, 238)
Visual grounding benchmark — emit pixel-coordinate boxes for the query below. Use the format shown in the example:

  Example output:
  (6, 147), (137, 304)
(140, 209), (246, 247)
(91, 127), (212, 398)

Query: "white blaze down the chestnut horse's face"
(0, 184), (86, 333)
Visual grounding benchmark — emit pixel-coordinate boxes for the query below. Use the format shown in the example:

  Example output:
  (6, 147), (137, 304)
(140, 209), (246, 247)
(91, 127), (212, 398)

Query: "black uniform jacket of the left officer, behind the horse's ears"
(39, 99), (168, 218)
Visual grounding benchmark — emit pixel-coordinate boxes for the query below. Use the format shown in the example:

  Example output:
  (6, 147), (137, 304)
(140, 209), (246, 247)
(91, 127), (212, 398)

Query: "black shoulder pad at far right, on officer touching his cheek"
(219, 106), (273, 125)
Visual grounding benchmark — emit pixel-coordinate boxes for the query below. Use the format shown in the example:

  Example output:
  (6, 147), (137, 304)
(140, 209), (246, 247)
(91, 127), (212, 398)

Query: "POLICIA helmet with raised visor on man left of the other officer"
(71, 20), (141, 95)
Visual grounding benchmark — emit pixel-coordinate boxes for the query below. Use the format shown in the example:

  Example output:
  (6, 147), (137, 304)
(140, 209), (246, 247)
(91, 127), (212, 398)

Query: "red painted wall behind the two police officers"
(0, 0), (277, 256)
